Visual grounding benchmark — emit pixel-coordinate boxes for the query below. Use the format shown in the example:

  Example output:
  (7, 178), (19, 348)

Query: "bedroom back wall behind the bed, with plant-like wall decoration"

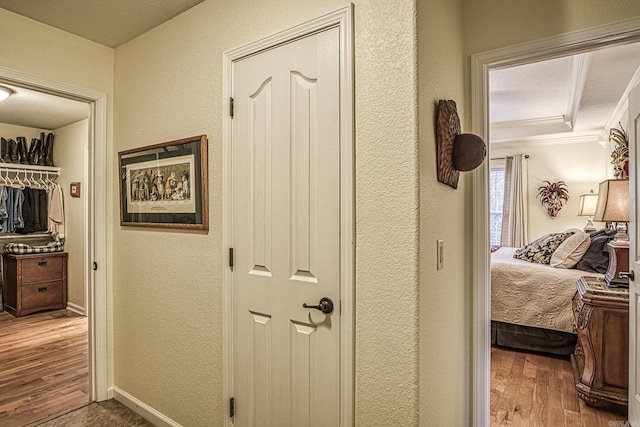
(491, 142), (610, 241)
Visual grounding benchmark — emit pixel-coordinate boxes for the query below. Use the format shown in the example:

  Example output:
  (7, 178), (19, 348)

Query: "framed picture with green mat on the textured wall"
(118, 135), (209, 230)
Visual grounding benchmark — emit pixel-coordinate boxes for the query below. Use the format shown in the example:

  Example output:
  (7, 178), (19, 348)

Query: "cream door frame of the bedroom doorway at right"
(471, 18), (640, 427)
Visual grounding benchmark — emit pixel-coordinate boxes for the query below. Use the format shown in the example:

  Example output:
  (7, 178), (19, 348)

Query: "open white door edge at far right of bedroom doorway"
(629, 85), (640, 425)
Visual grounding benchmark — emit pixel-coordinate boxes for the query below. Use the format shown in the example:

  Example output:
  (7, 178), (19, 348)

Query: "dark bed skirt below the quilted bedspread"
(491, 320), (578, 356)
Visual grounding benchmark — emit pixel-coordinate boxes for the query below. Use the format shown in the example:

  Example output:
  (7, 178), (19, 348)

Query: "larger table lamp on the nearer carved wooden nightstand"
(594, 179), (629, 287)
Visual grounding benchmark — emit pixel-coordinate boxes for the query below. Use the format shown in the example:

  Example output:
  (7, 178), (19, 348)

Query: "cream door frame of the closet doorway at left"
(0, 67), (109, 401)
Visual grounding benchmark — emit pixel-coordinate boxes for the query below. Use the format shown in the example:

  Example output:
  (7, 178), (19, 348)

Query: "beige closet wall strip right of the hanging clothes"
(53, 120), (89, 308)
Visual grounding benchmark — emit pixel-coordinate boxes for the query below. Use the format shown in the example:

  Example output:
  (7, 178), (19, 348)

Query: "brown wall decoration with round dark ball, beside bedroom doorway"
(436, 100), (487, 188)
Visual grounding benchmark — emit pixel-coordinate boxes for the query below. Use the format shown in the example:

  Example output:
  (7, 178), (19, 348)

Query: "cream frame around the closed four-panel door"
(222, 4), (355, 427)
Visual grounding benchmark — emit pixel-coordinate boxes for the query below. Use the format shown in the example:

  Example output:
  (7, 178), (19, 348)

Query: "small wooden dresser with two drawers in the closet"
(2, 252), (68, 317)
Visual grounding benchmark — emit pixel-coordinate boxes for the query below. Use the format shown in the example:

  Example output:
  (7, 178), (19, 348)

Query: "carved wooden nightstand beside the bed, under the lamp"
(571, 277), (629, 406)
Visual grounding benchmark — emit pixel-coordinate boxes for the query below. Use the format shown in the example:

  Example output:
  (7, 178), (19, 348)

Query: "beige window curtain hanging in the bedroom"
(500, 154), (528, 248)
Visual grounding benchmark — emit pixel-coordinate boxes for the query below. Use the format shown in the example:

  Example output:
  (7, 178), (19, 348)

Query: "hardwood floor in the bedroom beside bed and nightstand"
(491, 346), (627, 427)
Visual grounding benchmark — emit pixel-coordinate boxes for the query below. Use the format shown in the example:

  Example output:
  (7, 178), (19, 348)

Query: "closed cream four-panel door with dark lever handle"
(231, 27), (341, 427)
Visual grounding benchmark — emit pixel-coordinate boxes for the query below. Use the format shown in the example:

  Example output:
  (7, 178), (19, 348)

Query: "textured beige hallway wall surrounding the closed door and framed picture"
(111, 0), (418, 426)
